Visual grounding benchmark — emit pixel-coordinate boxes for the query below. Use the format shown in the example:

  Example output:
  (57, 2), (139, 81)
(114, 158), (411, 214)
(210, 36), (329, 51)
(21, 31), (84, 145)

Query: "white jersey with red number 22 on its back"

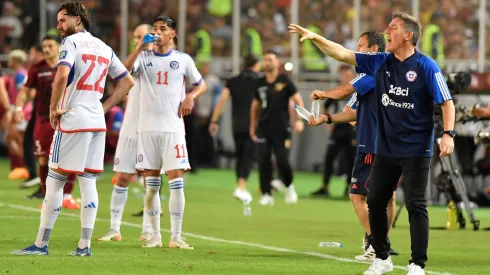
(58, 31), (128, 133)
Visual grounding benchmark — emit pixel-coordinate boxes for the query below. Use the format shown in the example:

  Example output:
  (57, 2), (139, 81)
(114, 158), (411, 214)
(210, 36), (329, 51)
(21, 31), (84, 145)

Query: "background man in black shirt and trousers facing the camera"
(250, 51), (304, 205)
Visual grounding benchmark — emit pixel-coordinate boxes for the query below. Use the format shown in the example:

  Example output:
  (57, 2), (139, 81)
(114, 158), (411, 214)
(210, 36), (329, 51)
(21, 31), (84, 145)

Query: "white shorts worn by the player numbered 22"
(49, 130), (105, 174)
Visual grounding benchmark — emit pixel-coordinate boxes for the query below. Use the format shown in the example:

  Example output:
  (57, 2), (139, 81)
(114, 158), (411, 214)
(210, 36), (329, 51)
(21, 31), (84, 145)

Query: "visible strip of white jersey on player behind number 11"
(119, 77), (141, 139)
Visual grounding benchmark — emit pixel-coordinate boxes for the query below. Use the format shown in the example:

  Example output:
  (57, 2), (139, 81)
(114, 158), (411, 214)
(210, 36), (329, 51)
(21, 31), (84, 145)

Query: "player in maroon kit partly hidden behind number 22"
(14, 35), (80, 209)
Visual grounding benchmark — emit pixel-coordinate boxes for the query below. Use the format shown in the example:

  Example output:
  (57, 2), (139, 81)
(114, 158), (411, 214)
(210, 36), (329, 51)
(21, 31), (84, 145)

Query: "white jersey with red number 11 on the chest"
(133, 50), (202, 134)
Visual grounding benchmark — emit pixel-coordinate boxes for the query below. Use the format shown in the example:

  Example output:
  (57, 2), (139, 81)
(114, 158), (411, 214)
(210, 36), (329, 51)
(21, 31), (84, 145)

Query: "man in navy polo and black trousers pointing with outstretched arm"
(289, 12), (455, 275)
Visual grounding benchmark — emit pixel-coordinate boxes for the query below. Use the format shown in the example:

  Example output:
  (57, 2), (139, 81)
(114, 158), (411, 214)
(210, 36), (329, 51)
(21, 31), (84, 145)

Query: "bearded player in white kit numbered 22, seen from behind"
(12, 2), (134, 256)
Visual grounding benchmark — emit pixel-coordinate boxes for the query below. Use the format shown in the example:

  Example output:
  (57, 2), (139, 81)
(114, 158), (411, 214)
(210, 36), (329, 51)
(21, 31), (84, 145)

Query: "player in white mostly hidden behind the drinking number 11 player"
(97, 24), (154, 244)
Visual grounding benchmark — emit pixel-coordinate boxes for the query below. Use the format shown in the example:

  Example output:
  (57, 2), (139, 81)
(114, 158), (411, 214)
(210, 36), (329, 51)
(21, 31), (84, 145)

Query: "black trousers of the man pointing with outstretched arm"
(367, 155), (430, 268)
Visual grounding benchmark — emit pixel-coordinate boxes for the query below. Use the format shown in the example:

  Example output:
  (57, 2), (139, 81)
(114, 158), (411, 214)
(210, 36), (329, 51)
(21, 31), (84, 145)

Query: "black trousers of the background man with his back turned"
(233, 133), (257, 180)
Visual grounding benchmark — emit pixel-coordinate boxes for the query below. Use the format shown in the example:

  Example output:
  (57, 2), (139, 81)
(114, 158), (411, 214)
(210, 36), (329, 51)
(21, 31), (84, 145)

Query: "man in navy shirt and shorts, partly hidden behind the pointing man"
(310, 32), (396, 261)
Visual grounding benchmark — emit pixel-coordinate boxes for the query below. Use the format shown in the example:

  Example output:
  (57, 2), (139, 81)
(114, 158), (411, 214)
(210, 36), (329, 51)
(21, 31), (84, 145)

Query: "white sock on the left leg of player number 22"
(35, 169), (67, 247)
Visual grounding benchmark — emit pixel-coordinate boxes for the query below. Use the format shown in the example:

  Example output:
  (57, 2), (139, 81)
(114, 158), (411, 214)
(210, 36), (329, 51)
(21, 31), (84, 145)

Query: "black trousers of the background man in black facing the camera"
(257, 130), (293, 195)
